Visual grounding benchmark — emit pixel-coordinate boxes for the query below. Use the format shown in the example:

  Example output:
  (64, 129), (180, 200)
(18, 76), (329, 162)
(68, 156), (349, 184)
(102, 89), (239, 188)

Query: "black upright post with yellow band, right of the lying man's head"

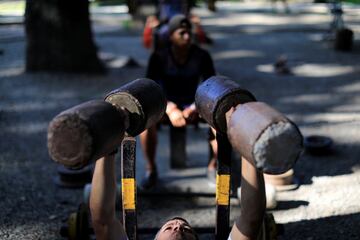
(215, 132), (232, 240)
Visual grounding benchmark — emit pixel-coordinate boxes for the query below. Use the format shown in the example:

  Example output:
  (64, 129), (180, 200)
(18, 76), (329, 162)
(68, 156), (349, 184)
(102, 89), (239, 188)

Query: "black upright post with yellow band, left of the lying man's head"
(121, 136), (137, 240)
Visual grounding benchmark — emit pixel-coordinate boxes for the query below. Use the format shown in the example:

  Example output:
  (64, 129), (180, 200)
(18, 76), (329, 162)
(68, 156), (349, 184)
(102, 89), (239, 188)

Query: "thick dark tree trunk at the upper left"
(25, 0), (105, 73)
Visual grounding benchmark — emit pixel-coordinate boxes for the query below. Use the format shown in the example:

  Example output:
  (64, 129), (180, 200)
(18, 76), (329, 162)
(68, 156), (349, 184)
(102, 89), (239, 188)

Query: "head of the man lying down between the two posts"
(154, 217), (199, 240)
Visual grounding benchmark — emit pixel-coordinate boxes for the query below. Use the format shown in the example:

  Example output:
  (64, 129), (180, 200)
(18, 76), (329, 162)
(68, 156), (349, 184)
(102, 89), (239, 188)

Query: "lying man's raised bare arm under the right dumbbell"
(230, 158), (266, 240)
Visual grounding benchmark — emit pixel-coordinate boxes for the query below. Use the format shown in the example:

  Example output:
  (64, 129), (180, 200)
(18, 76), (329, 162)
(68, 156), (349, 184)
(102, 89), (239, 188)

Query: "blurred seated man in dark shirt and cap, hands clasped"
(140, 15), (217, 189)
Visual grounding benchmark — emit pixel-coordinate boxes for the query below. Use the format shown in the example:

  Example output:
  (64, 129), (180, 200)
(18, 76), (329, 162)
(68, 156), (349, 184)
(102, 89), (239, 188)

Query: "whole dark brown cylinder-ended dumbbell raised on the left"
(48, 79), (166, 168)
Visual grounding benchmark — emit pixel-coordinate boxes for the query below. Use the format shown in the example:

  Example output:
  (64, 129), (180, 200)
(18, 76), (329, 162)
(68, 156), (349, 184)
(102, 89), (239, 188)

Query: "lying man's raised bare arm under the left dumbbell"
(90, 154), (128, 240)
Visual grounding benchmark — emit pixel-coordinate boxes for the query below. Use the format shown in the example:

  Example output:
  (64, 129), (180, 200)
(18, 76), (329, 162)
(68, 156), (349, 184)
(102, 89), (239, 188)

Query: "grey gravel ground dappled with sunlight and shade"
(0, 2), (360, 240)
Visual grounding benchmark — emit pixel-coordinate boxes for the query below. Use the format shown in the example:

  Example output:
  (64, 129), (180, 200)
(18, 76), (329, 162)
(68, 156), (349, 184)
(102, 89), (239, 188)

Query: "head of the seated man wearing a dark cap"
(168, 14), (192, 47)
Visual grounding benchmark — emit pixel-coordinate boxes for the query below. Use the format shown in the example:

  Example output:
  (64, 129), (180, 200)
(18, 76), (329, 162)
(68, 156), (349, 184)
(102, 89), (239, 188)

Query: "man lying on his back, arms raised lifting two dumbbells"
(90, 152), (265, 240)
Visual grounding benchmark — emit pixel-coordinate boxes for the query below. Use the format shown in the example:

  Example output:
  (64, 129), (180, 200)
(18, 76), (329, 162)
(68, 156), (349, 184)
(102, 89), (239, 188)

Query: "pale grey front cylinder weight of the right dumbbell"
(227, 102), (303, 174)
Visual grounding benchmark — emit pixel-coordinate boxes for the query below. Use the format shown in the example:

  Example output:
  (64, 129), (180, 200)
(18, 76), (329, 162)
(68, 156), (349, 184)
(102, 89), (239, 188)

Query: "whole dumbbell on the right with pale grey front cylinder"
(195, 76), (303, 174)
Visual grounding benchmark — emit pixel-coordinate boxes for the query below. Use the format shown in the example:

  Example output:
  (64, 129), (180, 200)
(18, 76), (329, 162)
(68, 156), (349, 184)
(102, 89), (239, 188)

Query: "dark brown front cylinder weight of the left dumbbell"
(47, 100), (128, 169)
